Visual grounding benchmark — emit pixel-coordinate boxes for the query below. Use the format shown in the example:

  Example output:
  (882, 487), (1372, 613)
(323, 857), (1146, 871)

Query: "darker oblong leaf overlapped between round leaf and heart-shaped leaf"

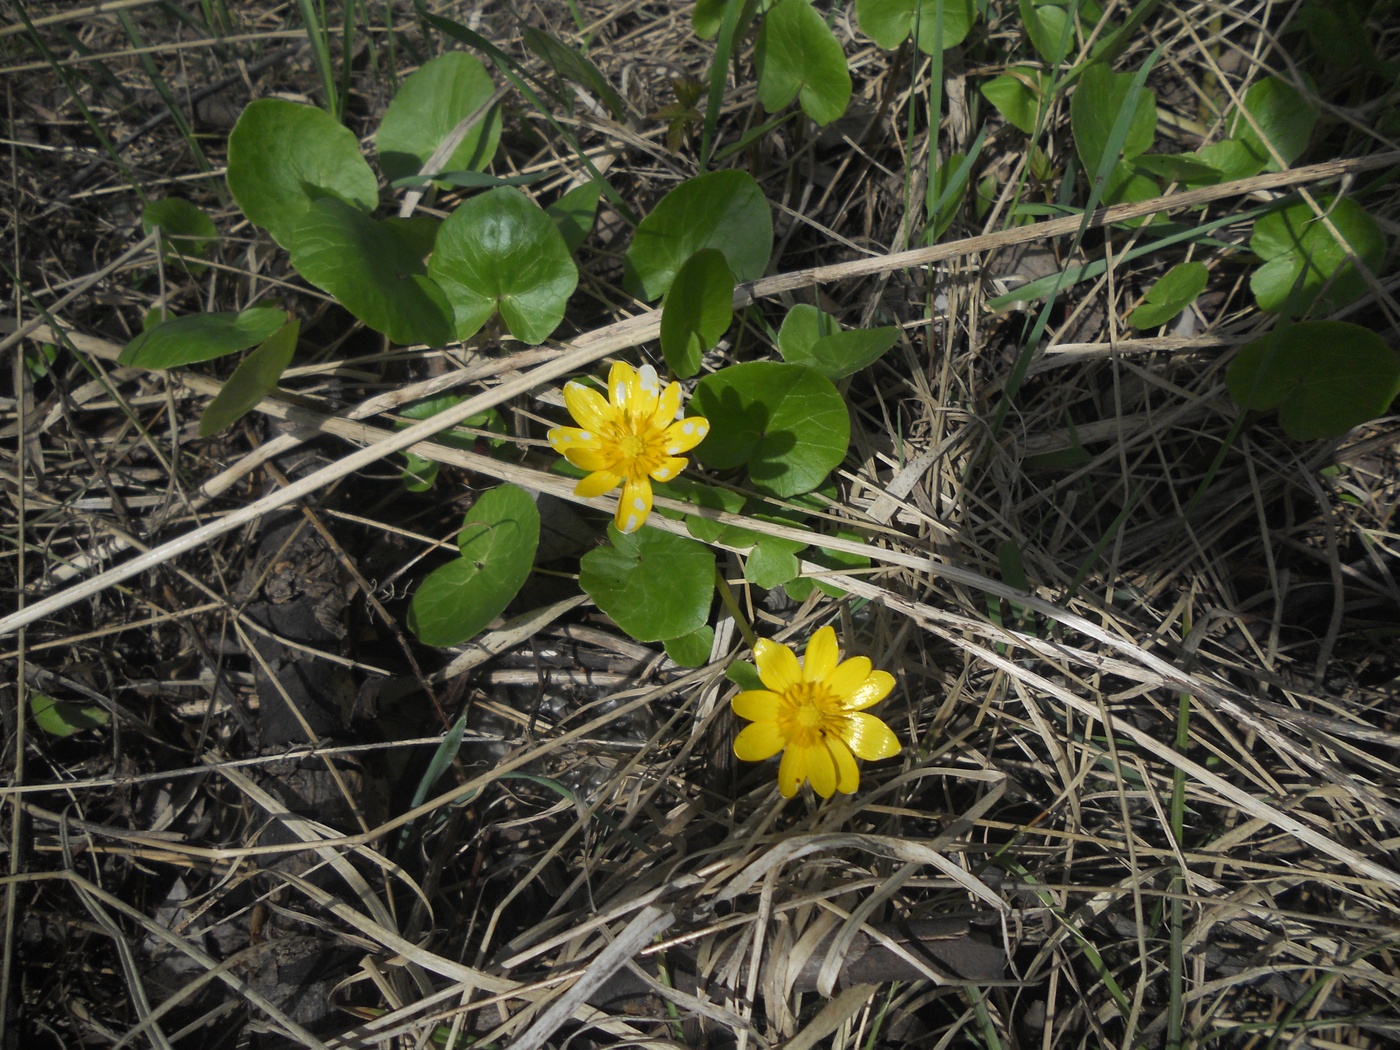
(287, 197), (452, 346)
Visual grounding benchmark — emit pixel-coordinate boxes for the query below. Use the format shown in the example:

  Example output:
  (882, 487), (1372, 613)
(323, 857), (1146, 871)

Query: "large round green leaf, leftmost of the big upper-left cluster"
(228, 98), (379, 248)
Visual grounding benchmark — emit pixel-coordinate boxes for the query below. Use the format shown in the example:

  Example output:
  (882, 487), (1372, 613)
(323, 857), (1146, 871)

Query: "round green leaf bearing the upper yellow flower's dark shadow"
(690, 361), (851, 496)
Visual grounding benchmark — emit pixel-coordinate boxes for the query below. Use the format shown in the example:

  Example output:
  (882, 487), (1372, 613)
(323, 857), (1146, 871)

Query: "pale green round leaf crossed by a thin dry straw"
(374, 50), (501, 181)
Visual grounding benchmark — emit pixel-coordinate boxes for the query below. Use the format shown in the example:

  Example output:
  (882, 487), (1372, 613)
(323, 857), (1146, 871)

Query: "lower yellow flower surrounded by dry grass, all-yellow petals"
(732, 627), (900, 798)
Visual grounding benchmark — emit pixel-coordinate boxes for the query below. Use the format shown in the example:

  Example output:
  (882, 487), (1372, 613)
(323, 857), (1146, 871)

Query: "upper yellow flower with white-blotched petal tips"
(547, 361), (710, 532)
